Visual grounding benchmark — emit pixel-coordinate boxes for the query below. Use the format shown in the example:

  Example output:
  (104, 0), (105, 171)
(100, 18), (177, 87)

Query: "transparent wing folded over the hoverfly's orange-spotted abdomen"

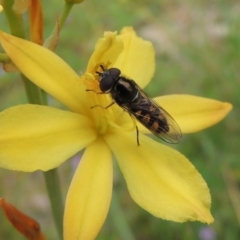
(122, 84), (182, 143)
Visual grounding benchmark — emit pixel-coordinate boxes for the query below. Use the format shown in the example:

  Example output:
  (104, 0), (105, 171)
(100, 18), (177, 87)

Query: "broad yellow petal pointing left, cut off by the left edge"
(0, 104), (96, 171)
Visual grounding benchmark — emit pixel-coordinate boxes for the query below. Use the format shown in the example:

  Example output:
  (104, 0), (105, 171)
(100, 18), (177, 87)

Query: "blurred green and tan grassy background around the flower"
(0, 0), (240, 240)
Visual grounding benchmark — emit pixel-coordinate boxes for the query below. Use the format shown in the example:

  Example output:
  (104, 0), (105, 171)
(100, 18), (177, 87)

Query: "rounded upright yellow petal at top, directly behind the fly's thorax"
(114, 27), (155, 88)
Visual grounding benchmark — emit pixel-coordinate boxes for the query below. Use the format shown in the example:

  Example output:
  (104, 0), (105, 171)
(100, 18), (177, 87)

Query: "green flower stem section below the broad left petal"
(44, 168), (63, 239)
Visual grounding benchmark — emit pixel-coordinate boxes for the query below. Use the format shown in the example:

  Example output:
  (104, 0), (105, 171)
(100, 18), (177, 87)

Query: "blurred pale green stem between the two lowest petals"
(110, 189), (135, 240)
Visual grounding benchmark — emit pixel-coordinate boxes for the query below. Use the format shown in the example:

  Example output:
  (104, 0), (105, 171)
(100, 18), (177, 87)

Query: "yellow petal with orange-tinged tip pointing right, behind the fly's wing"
(154, 94), (232, 133)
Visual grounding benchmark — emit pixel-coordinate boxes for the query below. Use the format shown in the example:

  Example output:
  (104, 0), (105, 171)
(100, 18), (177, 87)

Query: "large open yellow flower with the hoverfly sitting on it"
(0, 28), (232, 240)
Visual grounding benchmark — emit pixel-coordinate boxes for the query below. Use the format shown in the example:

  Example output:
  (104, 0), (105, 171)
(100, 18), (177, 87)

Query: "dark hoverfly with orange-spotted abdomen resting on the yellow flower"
(90, 65), (182, 145)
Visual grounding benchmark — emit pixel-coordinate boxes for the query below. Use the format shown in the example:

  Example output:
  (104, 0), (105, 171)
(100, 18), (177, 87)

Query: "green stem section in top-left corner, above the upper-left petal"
(2, 0), (25, 38)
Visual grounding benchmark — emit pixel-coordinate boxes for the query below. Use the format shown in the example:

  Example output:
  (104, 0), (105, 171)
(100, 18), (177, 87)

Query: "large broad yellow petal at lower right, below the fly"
(105, 130), (213, 223)
